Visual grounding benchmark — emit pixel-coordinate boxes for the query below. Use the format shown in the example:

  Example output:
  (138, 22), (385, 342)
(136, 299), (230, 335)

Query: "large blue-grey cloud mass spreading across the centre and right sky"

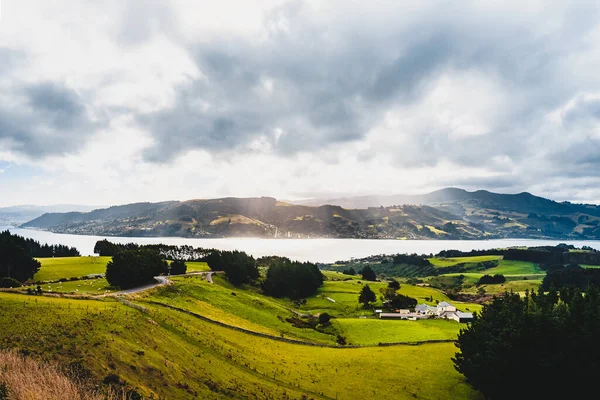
(140, 2), (597, 170)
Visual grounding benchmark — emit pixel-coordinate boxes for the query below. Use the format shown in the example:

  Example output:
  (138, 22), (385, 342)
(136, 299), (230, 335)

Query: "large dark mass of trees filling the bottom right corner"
(453, 286), (600, 399)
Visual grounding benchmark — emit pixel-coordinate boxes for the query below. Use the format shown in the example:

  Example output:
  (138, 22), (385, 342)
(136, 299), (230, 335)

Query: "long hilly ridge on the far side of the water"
(22, 188), (600, 239)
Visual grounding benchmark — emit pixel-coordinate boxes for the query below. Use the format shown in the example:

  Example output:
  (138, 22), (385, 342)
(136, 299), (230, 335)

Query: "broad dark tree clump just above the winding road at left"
(106, 249), (168, 289)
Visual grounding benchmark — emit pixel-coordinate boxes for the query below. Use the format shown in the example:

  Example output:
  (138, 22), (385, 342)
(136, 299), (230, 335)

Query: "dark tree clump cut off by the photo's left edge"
(0, 231), (41, 282)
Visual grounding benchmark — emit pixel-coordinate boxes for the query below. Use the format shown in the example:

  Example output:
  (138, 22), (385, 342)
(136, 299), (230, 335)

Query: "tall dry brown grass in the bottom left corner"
(0, 350), (124, 400)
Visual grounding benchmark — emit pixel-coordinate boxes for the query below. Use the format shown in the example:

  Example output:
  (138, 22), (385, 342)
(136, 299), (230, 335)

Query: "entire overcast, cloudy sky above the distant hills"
(0, 0), (600, 206)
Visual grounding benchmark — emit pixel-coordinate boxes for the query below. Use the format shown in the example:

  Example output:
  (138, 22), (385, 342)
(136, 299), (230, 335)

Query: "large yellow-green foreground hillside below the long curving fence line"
(0, 293), (480, 400)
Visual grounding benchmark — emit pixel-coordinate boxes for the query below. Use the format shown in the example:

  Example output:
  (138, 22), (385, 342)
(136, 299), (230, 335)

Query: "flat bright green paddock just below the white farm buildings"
(332, 318), (466, 345)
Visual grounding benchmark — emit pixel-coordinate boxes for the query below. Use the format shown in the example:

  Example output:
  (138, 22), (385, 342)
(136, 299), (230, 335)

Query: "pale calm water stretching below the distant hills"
(0, 227), (600, 263)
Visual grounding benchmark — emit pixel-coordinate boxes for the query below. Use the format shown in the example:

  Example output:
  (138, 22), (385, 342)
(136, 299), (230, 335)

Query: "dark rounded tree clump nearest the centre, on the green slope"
(262, 259), (323, 299)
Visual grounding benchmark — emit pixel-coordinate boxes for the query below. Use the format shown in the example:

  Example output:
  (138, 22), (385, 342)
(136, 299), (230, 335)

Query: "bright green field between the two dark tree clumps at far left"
(33, 256), (112, 281)
